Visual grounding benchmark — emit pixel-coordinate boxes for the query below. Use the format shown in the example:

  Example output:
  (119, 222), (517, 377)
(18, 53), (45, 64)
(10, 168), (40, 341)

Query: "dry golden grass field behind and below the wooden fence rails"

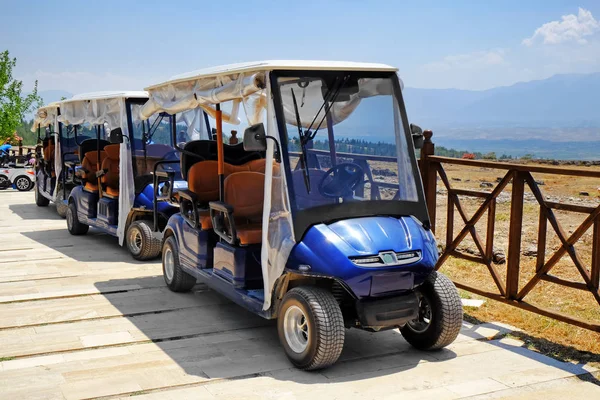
(436, 165), (600, 365)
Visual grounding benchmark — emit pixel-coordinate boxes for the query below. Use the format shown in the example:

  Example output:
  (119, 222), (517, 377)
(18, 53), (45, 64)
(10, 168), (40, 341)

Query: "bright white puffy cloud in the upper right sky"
(522, 8), (600, 46)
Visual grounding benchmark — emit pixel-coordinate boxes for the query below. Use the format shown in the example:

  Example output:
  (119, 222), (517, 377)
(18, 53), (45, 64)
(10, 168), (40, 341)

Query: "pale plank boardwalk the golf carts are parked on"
(0, 191), (600, 400)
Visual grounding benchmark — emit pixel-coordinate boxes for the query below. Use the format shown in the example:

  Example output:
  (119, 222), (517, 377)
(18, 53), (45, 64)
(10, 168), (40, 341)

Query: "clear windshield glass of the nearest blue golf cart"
(278, 73), (419, 214)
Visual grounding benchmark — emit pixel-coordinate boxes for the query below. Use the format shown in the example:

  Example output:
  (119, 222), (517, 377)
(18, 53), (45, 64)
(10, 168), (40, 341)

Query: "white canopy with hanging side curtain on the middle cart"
(58, 91), (148, 245)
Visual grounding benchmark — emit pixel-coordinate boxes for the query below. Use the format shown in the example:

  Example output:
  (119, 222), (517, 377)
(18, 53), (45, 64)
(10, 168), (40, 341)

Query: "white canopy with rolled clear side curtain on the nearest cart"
(141, 61), (397, 310)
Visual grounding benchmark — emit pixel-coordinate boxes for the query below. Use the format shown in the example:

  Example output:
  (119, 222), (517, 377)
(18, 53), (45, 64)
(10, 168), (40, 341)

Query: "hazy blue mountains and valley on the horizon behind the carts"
(40, 73), (600, 160)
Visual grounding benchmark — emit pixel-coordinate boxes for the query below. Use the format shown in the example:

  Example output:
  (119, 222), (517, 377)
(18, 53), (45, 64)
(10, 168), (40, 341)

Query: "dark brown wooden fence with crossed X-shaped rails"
(419, 131), (600, 332)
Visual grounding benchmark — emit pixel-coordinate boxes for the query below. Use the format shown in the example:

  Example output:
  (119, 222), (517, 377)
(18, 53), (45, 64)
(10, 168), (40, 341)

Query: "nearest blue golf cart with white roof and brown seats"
(141, 61), (462, 370)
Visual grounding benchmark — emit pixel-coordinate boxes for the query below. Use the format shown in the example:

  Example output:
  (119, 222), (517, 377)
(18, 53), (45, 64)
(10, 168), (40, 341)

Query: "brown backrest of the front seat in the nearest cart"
(224, 171), (265, 222)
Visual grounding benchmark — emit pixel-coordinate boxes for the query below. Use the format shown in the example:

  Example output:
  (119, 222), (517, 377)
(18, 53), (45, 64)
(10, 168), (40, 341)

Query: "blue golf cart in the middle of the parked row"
(60, 92), (197, 260)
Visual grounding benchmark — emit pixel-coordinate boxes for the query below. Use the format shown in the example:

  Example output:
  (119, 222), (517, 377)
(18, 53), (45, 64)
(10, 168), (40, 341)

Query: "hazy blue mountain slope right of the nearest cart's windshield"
(404, 73), (600, 128)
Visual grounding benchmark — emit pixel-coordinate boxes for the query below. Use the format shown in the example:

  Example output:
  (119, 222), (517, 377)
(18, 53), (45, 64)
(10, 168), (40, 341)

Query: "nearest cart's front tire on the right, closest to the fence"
(400, 272), (463, 350)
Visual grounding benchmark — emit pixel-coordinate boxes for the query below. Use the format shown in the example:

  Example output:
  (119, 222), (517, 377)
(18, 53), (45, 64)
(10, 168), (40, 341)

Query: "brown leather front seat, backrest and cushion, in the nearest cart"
(225, 171), (265, 245)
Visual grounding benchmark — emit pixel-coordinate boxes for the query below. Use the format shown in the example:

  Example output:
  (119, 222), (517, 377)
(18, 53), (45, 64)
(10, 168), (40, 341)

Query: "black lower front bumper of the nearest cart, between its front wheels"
(356, 292), (419, 329)
